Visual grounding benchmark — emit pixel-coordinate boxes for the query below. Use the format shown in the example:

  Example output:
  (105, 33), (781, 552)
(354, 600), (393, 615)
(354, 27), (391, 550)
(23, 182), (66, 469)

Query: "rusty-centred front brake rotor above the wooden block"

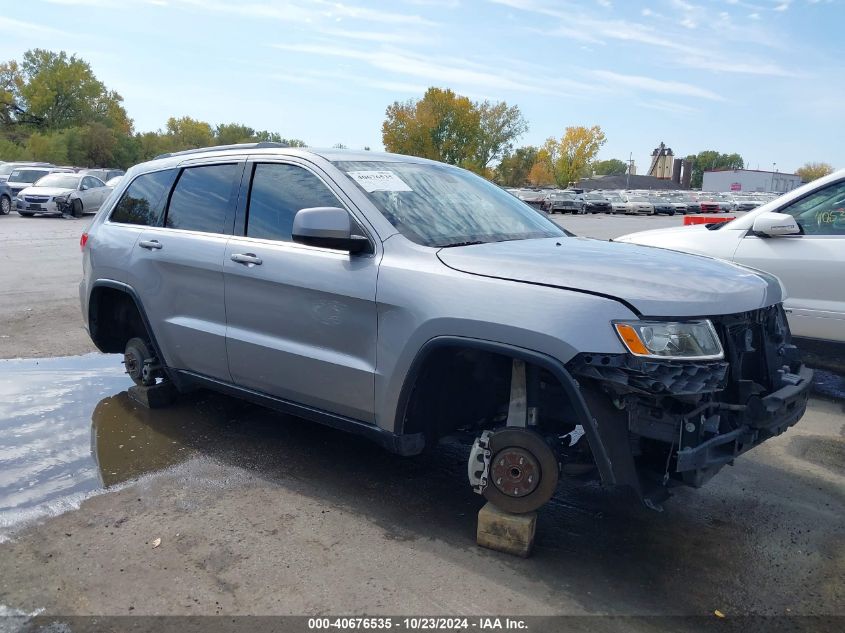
(483, 427), (560, 514)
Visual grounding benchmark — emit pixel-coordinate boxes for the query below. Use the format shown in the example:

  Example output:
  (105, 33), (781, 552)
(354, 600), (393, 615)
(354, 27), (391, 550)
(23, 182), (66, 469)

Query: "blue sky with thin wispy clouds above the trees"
(0, 0), (845, 173)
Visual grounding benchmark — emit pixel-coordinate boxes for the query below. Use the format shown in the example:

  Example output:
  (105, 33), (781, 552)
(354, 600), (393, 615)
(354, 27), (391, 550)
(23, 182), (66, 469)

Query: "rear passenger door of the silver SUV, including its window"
(127, 159), (243, 382)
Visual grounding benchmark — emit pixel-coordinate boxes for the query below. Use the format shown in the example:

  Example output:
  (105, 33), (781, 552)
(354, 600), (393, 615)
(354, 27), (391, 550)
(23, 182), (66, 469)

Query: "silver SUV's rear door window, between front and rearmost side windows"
(165, 163), (240, 233)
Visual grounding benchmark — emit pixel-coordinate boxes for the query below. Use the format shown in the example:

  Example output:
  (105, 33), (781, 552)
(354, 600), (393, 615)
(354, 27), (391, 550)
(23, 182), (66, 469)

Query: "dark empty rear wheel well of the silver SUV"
(88, 288), (150, 353)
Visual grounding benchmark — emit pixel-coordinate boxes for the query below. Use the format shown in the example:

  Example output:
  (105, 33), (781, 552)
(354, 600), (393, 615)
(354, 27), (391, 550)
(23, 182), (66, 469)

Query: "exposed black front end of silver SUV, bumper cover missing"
(567, 305), (812, 502)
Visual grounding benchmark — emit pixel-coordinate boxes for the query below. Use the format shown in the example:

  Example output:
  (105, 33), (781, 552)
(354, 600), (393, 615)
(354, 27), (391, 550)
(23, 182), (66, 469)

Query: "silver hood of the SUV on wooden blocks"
(438, 237), (782, 317)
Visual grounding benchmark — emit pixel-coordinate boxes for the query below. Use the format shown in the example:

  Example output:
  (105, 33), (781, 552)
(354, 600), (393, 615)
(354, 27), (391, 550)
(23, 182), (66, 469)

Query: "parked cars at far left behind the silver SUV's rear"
(0, 162), (124, 217)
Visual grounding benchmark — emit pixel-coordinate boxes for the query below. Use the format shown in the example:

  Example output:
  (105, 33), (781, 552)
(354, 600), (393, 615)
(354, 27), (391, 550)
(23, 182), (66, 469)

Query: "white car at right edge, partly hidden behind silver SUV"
(613, 169), (845, 346)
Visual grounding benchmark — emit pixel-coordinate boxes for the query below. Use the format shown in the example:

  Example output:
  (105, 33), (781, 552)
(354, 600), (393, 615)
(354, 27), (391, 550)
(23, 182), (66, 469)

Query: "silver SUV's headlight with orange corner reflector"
(613, 319), (725, 360)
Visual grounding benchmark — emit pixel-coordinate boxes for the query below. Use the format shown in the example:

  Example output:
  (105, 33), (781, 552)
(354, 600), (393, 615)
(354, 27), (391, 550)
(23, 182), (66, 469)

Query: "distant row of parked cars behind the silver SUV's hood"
(507, 189), (774, 215)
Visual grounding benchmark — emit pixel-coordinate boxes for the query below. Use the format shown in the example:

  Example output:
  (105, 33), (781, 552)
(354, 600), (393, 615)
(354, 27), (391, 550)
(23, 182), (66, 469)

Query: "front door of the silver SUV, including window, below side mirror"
(223, 160), (378, 422)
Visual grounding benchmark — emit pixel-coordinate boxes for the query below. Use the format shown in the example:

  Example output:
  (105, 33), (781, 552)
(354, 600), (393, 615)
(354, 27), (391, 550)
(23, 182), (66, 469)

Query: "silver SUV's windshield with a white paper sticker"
(335, 161), (566, 247)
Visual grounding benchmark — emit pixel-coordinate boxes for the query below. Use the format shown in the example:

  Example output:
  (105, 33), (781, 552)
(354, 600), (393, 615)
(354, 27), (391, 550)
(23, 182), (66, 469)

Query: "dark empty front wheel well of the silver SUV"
(402, 346), (576, 445)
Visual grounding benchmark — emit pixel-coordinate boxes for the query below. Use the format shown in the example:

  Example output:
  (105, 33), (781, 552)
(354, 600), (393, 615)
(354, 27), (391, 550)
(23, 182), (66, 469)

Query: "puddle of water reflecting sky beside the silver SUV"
(0, 354), (237, 541)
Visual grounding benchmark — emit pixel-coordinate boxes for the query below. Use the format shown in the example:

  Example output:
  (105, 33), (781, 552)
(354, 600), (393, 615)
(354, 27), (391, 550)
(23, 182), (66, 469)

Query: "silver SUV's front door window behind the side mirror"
(246, 163), (341, 242)
